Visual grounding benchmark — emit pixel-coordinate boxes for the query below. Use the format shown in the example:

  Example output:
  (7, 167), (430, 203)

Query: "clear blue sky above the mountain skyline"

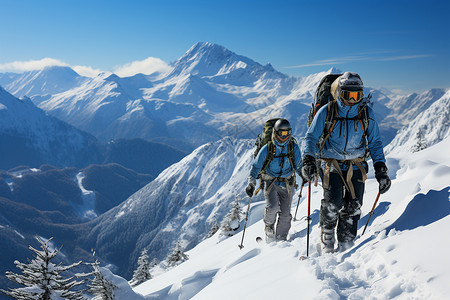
(0, 0), (450, 92)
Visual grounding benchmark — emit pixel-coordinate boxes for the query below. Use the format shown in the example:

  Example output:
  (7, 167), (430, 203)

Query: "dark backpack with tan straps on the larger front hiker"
(308, 74), (372, 155)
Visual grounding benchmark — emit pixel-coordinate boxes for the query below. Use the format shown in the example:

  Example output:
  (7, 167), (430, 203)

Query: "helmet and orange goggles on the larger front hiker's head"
(331, 72), (364, 106)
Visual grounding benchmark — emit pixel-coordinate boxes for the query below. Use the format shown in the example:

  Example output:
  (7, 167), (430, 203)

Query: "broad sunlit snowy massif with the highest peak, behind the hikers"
(0, 42), (393, 151)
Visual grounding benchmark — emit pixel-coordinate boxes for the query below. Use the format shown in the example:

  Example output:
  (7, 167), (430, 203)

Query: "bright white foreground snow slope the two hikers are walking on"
(134, 138), (450, 299)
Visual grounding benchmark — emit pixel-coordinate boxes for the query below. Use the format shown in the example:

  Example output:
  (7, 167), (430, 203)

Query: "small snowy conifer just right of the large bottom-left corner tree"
(85, 260), (117, 300)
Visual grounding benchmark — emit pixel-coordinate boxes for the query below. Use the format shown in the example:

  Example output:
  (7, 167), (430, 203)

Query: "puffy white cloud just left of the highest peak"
(113, 57), (172, 77)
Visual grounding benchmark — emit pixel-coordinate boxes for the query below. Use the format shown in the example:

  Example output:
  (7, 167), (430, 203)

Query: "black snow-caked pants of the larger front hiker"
(320, 170), (364, 242)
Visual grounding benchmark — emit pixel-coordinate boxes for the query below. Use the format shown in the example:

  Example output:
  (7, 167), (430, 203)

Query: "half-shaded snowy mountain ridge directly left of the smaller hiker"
(82, 137), (253, 276)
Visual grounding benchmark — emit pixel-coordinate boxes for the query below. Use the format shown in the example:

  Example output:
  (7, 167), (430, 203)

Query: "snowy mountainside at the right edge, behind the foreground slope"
(385, 89), (450, 153)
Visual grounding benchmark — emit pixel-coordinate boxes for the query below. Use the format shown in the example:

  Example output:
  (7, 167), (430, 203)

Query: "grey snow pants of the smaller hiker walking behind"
(264, 184), (295, 240)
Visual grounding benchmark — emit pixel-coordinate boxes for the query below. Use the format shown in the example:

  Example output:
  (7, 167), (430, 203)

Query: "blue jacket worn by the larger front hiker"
(302, 101), (386, 168)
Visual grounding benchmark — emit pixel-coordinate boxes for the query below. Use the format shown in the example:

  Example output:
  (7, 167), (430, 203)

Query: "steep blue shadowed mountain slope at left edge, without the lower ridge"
(0, 87), (97, 169)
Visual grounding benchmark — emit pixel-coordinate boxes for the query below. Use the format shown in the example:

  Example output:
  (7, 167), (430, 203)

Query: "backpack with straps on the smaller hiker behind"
(253, 118), (297, 177)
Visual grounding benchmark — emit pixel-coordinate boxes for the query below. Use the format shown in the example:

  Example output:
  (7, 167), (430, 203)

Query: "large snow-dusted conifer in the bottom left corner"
(1, 236), (85, 300)
